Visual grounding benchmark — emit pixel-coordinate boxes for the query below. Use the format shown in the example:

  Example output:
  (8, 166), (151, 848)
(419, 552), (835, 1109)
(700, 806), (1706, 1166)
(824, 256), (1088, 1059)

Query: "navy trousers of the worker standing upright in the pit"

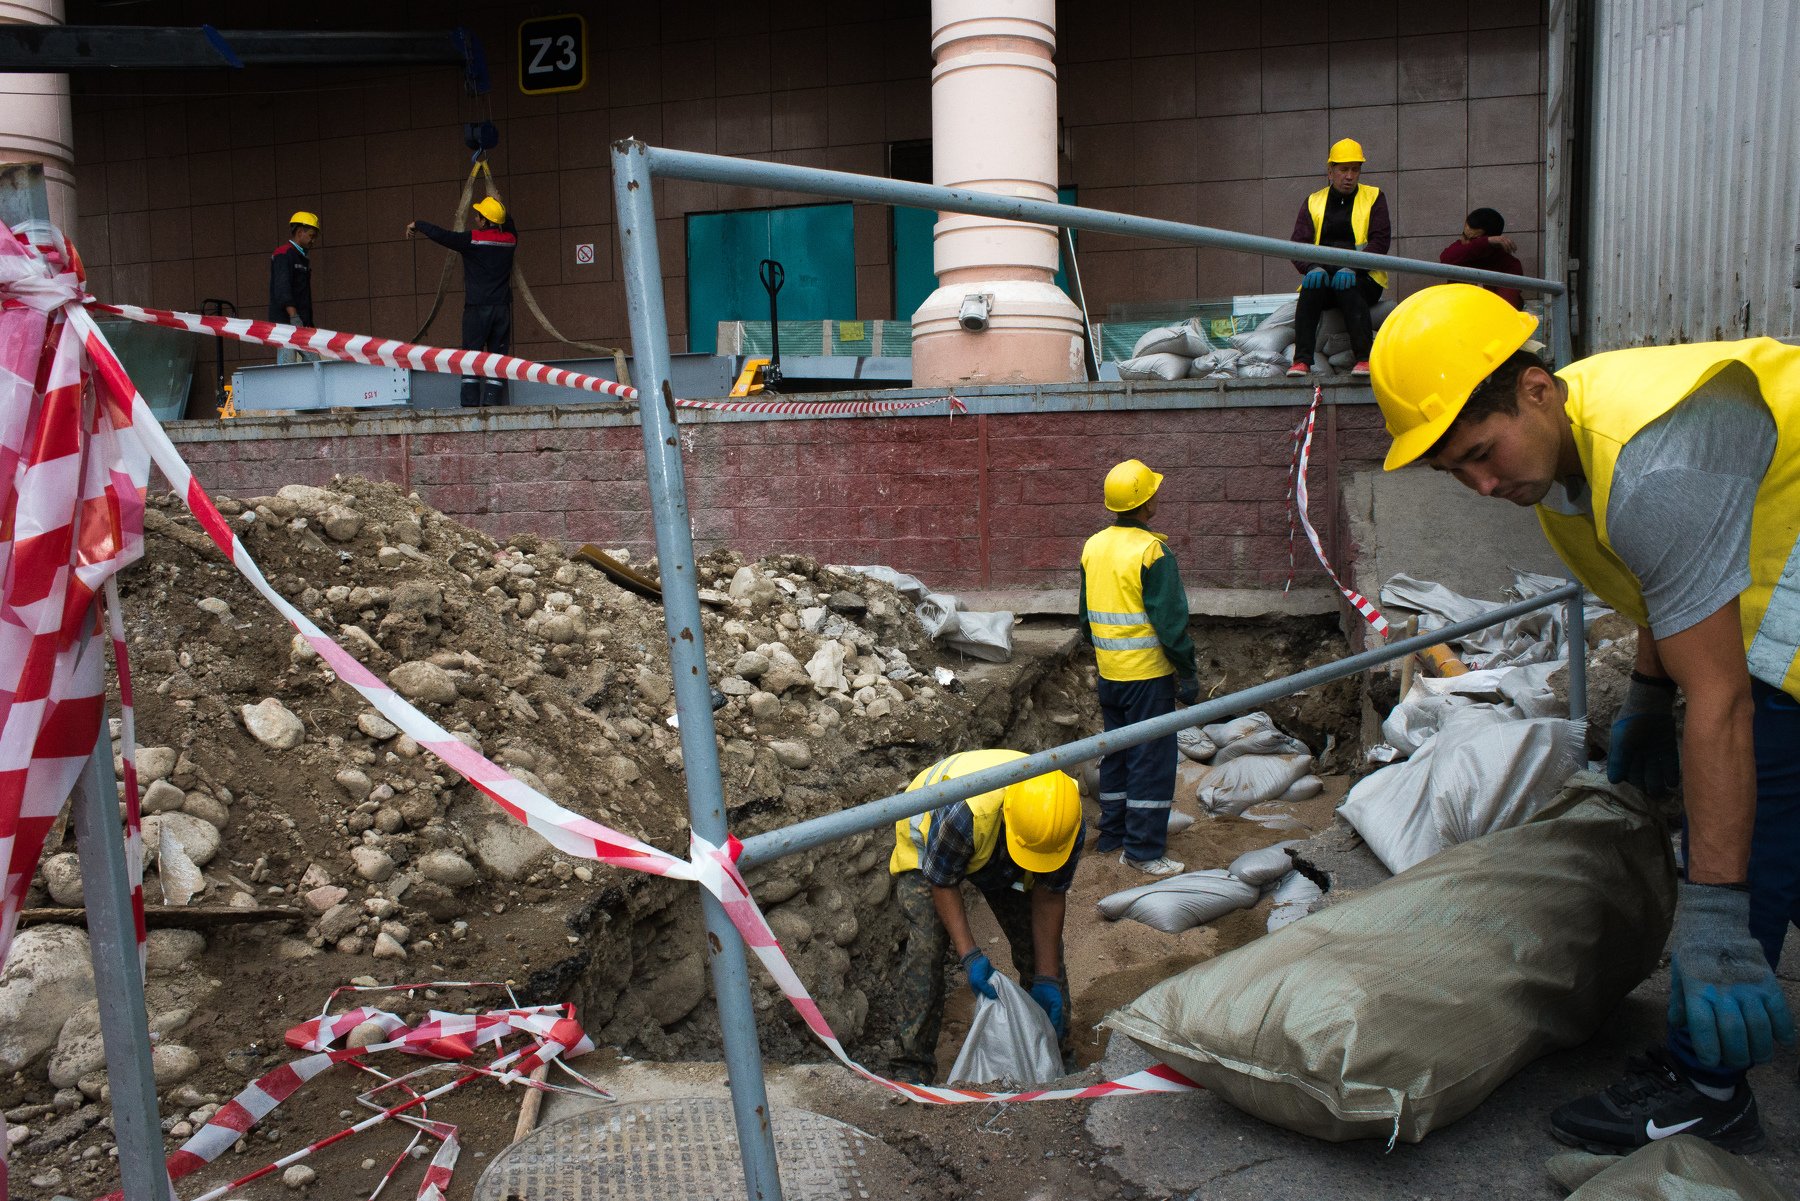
(1100, 675), (1179, 862)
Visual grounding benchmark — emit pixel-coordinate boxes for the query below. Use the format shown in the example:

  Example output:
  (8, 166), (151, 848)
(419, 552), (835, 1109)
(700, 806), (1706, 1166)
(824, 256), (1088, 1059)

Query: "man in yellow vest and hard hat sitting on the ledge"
(1287, 137), (1393, 376)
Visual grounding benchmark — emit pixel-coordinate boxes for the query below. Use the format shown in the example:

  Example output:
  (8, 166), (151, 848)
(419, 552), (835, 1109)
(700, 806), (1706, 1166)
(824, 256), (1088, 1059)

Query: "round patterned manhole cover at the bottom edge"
(475, 1098), (907, 1201)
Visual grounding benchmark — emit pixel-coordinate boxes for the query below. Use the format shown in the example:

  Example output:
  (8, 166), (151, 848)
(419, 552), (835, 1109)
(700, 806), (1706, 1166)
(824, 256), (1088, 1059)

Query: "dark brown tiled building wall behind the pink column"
(68, 0), (1543, 414)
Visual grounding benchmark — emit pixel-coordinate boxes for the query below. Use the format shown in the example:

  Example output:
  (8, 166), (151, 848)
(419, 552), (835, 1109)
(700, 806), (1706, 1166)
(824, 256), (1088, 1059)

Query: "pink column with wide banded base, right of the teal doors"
(913, 0), (1085, 385)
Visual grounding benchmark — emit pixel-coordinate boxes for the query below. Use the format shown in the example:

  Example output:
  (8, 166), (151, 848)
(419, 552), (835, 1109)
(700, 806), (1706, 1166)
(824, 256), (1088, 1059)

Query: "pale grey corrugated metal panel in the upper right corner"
(1582, 0), (1800, 351)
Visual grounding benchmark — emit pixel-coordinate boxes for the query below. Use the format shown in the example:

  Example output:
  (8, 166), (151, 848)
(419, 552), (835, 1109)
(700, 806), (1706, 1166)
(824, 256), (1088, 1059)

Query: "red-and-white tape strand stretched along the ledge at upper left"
(88, 303), (968, 416)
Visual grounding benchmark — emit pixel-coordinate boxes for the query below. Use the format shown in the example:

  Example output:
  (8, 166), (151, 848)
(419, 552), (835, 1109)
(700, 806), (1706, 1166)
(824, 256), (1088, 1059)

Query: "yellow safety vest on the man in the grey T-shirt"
(1537, 339), (1800, 697)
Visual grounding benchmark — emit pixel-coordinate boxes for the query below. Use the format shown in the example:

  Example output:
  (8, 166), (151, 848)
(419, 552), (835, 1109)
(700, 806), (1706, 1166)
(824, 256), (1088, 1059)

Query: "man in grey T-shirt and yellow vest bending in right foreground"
(1373, 284), (1800, 1152)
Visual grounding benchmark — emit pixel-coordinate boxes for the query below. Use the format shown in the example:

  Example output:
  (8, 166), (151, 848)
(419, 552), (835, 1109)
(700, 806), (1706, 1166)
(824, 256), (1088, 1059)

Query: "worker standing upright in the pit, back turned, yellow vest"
(1078, 459), (1201, 875)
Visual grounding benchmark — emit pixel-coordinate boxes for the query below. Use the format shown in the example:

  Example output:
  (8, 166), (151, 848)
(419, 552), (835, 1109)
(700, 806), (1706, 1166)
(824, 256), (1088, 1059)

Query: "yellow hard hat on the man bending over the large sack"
(1368, 283), (1537, 472)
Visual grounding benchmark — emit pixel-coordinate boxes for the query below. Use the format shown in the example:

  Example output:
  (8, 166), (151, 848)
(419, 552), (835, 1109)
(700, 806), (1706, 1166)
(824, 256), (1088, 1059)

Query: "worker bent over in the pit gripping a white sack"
(887, 751), (1082, 1084)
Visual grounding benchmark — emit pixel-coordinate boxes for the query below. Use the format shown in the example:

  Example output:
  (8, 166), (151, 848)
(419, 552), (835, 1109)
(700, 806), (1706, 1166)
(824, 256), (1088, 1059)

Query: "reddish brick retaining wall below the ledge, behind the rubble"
(171, 400), (1386, 589)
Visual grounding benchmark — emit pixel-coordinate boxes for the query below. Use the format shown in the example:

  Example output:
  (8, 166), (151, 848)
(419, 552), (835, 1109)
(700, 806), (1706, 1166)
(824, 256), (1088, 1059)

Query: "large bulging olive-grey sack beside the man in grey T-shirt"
(1103, 772), (1676, 1142)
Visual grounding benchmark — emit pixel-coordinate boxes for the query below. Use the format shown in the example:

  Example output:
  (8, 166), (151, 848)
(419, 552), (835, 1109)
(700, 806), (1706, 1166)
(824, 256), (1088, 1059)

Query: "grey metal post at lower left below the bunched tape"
(70, 727), (175, 1197)
